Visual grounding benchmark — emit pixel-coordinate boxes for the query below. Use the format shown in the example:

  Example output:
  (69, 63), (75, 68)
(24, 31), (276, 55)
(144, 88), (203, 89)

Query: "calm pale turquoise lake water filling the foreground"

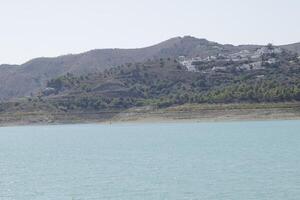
(0, 121), (300, 200)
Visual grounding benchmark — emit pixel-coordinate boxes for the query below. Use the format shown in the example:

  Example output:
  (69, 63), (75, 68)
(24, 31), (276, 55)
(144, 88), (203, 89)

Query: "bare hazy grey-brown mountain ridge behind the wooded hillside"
(0, 36), (299, 101)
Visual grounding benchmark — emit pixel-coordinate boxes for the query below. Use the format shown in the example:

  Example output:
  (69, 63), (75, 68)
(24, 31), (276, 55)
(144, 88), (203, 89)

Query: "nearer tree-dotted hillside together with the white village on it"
(42, 46), (300, 109)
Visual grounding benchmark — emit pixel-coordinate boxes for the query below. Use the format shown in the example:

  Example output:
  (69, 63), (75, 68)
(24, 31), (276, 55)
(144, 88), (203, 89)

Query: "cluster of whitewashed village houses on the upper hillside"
(178, 44), (300, 73)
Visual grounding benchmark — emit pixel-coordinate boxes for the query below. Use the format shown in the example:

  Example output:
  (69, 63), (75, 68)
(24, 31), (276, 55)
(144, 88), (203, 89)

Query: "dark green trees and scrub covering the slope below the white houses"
(0, 45), (300, 117)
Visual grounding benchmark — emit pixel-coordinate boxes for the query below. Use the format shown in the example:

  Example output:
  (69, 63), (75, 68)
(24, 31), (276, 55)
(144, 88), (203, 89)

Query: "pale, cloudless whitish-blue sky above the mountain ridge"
(0, 0), (300, 64)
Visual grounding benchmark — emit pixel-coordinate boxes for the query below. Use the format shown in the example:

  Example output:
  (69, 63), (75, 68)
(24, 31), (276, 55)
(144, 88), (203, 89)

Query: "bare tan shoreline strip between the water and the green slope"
(0, 102), (300, 127)
